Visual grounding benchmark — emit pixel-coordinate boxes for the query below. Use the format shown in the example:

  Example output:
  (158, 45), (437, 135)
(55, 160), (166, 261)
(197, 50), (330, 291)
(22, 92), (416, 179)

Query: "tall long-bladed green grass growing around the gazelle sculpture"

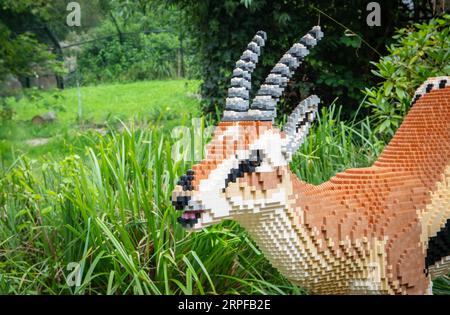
(0, 105), (448, 294)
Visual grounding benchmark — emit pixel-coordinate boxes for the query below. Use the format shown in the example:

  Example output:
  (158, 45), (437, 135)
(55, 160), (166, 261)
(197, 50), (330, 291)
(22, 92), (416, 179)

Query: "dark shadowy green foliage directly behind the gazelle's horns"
(172, 0), (420, 116)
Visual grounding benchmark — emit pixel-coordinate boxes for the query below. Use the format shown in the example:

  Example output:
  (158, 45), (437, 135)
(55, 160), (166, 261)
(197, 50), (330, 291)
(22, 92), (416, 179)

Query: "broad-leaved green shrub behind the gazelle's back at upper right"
(365, 15), (450, 139)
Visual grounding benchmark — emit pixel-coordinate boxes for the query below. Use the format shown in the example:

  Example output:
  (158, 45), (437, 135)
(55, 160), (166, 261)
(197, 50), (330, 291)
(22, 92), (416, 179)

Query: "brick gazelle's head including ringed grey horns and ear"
(172, 26), (323, 230)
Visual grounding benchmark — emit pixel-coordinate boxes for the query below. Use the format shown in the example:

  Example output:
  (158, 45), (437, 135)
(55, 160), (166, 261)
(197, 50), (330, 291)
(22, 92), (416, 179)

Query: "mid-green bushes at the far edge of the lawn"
(75, 1), (196, 84)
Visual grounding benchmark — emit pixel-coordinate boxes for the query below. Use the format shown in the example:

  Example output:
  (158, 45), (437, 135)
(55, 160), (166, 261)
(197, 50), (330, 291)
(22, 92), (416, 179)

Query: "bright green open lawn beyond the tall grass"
(0, 80), (200, 163)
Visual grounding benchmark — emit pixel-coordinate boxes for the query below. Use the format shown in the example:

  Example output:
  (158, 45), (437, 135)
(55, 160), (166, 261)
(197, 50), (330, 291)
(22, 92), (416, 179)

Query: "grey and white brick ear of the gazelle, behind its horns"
(283, 95), (320, 161)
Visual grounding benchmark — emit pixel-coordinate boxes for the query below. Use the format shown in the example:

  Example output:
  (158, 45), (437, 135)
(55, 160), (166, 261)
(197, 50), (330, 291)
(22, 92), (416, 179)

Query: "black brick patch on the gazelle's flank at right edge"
(425, 219), (450, 273)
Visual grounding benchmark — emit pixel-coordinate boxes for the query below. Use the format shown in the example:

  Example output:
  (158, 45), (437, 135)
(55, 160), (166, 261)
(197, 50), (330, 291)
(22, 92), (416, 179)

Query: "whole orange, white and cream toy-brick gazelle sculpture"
(172, 26), (450, 294)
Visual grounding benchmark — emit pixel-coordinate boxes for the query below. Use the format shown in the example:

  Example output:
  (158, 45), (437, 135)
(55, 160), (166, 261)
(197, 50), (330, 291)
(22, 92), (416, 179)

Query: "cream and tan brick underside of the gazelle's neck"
(237, 169), (398, 294)
